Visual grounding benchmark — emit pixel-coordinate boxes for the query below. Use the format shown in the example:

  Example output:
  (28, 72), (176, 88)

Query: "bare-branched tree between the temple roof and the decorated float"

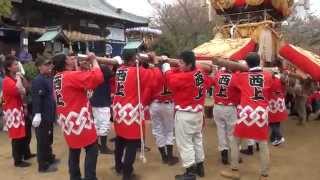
(149, 0), (221, 56)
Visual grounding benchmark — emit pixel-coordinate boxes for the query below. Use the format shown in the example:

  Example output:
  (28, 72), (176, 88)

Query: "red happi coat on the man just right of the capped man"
(53, 68), (104, 148)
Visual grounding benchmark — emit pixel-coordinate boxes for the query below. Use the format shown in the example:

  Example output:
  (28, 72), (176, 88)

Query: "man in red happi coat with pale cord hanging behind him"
(112, 50), (161, 180)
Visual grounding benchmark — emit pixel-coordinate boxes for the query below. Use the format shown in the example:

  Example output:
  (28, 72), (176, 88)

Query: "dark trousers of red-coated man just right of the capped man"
(69, 142), (98, 180)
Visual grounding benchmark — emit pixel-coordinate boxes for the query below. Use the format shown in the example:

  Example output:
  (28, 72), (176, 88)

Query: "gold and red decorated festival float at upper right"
(193, 0), (320, 81)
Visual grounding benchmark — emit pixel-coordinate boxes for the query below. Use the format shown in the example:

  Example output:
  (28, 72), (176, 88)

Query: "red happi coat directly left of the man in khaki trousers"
(212, 71), (240, 106)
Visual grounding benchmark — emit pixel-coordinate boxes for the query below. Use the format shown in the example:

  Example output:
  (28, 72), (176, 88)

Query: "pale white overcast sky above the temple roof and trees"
(106, 0), (320, 17)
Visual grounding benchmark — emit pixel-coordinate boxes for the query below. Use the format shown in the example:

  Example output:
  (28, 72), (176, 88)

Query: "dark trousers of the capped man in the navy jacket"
(36, 120), (54, 170)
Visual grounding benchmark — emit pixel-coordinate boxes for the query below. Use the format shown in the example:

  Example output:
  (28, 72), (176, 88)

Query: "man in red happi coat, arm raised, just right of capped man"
(52, 54), (103, 180)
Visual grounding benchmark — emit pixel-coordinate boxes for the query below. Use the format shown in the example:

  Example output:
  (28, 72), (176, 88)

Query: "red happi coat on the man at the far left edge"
(2, 76), (26, 139)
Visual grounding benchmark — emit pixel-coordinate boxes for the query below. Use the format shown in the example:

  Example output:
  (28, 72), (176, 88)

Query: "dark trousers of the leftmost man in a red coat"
(11, 137), (26, 165)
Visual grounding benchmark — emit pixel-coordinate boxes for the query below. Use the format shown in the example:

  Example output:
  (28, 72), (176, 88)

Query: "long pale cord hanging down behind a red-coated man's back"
(136, 59), (147, 163)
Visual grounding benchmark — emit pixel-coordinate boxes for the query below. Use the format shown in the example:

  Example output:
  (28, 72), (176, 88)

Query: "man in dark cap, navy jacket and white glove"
(31, 58), (57, 172)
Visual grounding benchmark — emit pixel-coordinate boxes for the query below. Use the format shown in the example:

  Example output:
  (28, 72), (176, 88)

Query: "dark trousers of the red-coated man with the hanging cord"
(114, 136), (141, 178)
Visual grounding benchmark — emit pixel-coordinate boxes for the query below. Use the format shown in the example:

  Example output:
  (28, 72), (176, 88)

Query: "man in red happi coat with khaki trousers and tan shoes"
(221, 53), (274, 180)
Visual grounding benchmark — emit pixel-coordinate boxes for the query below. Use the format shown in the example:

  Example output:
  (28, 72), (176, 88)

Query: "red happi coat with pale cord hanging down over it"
(112, 65), (161, 139)
